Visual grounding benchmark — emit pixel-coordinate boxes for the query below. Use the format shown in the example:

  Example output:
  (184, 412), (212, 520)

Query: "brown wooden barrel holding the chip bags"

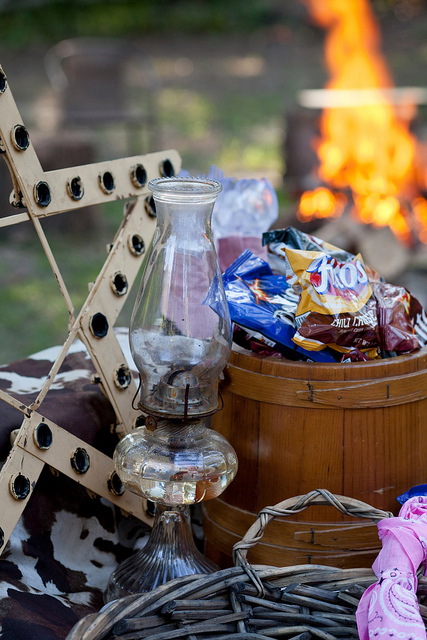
(203, 348), (427, 568)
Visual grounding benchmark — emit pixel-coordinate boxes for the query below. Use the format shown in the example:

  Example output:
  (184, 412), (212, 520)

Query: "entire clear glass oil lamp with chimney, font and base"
(105, 177), (237, 600)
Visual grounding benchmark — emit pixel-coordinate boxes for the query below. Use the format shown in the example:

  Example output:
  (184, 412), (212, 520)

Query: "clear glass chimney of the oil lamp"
(130, 178), (231, 419)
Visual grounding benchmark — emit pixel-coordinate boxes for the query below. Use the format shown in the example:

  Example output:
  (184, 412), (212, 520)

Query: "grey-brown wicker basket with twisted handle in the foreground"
(67, 489), (427, 640)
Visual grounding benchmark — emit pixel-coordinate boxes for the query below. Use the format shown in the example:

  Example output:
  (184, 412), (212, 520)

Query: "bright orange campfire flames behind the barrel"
(298, 0), (427, 243)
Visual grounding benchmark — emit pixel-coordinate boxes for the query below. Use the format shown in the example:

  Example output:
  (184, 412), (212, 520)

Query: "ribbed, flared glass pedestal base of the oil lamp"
(104, 504), (218, 602)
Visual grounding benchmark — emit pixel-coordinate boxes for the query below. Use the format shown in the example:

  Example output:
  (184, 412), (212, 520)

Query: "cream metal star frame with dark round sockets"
(0, 67), (181, 551)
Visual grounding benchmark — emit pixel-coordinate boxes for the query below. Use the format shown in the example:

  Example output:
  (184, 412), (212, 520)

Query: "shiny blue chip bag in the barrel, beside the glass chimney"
(222, 249), (337, 362)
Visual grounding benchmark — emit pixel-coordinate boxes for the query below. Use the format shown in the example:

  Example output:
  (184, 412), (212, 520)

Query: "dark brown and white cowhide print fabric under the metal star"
(0, 334), (148, 640)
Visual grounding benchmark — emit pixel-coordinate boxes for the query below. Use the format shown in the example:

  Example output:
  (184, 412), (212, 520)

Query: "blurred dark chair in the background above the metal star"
(44, 38), (159, 157)
